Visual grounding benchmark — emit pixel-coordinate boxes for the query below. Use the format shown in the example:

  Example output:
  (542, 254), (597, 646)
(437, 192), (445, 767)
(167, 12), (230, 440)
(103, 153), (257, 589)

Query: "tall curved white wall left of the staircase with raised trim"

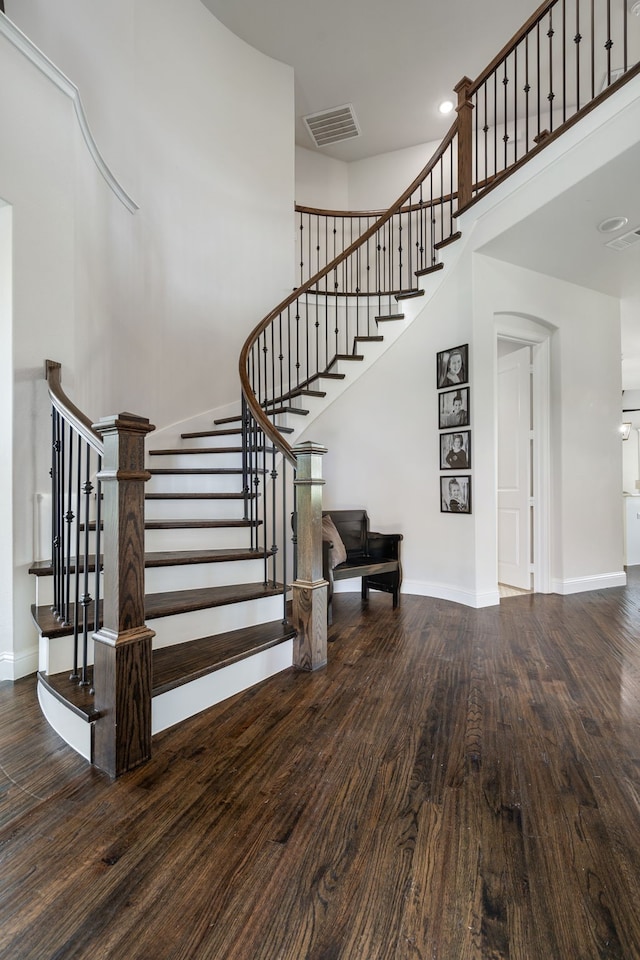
(0, 0), (294, 676)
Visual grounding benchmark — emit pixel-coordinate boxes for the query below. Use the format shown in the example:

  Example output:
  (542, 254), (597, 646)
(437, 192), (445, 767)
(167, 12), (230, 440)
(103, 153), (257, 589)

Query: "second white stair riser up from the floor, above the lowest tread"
(147, 596), (283, 650)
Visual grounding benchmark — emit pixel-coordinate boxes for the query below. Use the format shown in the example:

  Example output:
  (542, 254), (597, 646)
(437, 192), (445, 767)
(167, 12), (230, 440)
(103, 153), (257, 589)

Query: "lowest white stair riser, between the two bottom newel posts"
(151, 640), (293, 734)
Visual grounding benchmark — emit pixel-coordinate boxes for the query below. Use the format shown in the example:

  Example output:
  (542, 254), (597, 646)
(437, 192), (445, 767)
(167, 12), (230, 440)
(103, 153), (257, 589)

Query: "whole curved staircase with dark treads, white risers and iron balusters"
(31, 0), (640, 775)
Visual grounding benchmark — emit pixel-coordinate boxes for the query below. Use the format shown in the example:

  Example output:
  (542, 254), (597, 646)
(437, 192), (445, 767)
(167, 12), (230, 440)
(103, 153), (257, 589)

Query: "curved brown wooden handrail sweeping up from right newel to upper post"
(239, 118), (458, 466)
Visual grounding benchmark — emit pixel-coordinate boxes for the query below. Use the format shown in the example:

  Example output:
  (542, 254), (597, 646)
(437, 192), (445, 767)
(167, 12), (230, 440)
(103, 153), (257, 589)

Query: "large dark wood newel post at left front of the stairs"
(93, 413), (155, 777)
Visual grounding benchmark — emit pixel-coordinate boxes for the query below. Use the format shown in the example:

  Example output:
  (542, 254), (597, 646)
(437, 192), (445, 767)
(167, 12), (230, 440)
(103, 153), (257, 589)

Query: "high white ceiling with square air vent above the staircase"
(202, 0), (537, 161)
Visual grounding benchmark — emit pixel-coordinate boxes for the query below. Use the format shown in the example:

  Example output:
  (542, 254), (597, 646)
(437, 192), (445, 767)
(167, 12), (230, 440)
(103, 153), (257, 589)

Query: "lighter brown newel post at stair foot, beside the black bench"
(292, 441), (328, 670)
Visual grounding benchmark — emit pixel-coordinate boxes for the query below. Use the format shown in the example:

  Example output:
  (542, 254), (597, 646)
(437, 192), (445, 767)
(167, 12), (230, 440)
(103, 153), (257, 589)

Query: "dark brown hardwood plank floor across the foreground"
(0, 568), (640, 960)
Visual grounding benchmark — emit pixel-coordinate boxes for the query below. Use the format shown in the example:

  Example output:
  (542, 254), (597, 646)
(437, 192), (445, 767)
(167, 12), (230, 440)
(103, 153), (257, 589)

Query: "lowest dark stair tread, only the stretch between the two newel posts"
(153, 620), (296, 696)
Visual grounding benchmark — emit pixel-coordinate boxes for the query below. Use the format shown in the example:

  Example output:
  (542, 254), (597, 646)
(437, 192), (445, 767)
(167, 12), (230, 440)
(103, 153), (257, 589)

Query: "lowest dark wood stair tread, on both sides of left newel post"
(38, 620), (296, 723)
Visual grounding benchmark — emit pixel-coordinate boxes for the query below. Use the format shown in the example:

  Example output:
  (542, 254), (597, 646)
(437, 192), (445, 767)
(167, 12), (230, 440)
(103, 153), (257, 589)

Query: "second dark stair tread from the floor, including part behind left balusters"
(31, 583), (282, 637)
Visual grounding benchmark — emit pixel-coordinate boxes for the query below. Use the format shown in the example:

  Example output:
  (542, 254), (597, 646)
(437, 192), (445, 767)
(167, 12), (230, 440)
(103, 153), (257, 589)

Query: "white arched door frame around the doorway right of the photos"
(495, 313), (553, 593)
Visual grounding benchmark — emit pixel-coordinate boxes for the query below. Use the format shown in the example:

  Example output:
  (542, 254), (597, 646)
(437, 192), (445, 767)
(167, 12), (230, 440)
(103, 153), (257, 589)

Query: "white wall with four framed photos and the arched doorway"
(303, 241), (623, 606)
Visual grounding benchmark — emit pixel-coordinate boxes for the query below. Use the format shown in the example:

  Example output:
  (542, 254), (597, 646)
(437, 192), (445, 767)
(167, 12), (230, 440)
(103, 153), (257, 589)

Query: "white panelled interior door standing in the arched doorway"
(498, 346), (532, 590)
